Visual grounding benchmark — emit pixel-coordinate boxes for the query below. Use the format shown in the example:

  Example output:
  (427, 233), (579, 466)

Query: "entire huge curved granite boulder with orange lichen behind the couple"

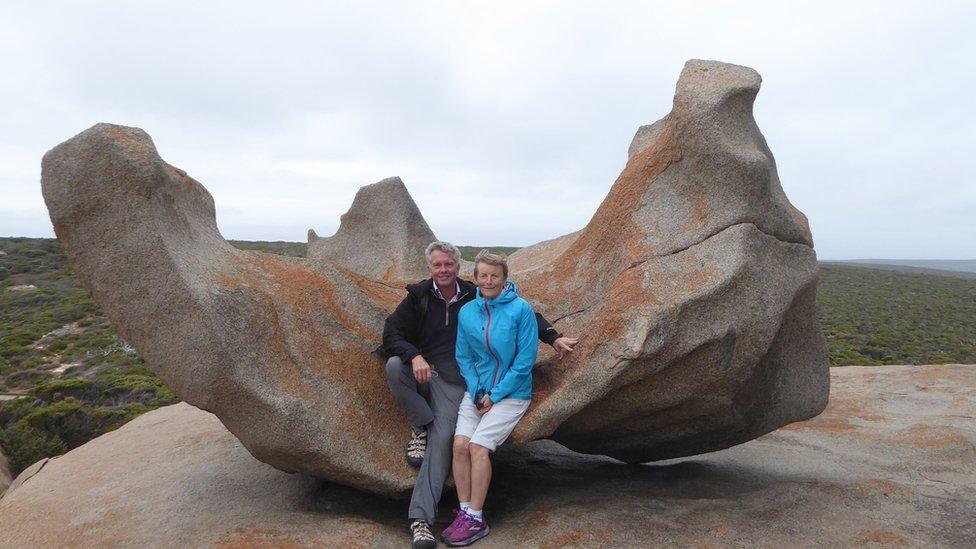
(42, 61), (828, 495)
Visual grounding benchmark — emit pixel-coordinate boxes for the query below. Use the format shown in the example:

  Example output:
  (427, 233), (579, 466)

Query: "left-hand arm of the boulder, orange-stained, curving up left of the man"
(42, 124), (413, 493)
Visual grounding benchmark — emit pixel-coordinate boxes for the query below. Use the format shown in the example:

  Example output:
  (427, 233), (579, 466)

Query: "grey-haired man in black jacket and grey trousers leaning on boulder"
(377, 241), (579, 549)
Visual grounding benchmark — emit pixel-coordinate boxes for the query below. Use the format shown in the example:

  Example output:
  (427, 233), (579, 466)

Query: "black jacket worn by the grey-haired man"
(376, 278), (560, 383)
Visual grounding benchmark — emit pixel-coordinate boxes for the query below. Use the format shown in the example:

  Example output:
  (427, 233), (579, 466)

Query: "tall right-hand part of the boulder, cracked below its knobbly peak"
(514, 57), (829, 462)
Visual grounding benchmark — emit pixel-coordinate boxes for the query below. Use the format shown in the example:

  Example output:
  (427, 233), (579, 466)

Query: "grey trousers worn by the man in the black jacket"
(386, 356), (465, 524)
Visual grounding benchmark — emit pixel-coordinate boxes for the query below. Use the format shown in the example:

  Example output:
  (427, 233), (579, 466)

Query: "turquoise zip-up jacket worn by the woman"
(455, 281), (539, 402)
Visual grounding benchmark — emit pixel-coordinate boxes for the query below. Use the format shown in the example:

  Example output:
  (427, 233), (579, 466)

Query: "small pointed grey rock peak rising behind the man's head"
(306, 177), (436, 282)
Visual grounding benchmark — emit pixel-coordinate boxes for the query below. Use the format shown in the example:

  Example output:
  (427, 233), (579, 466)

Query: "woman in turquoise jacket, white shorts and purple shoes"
(443, 250), (539, 545)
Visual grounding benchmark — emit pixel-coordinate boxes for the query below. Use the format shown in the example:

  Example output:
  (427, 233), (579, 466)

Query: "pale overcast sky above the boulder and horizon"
(0, 0), (976, 259)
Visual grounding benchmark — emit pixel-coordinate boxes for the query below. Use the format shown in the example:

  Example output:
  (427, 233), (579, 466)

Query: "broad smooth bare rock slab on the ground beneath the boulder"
(0, 365), (976, 548)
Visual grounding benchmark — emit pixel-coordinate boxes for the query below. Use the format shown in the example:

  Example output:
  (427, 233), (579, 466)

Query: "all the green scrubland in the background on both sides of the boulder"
(0, 238), (976, 474)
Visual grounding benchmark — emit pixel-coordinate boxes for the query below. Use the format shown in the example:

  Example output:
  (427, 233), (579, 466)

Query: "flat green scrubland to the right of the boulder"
(817, 265), (976, 365)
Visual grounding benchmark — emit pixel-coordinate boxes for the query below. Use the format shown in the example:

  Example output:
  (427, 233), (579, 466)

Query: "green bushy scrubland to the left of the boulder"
(0, 238), (178, 474)
